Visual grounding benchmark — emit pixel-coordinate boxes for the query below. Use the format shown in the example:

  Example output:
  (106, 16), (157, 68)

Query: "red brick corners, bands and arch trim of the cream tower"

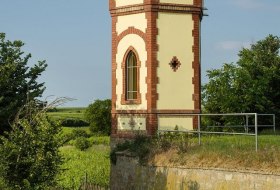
(109, 0), (202, 138)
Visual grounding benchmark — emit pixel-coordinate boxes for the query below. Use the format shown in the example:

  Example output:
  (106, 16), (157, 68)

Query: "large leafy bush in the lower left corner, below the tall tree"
(0, 101), (62, 190)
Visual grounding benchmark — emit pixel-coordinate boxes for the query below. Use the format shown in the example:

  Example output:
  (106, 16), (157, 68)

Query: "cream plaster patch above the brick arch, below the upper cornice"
(116, 13), (147, 35)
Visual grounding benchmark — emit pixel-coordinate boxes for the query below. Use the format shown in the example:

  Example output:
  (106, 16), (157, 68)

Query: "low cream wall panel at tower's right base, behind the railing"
(158, 117), (193, 130)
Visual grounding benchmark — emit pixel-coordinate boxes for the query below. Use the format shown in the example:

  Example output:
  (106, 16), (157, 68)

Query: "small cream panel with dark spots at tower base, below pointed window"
(118, 116), (146, 130)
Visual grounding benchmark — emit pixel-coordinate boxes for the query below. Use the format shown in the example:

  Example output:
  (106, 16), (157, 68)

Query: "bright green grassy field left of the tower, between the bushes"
(47, 108), (110, 190)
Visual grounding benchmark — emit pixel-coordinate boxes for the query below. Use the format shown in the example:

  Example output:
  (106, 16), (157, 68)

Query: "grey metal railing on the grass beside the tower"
(158, 113), (276, 151)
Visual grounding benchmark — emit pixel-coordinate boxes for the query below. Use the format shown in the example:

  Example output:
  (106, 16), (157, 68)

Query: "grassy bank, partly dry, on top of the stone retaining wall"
(111, 132), (280, 173)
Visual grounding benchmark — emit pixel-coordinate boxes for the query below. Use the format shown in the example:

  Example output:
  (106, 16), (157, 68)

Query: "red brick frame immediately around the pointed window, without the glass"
(121, 46), (141, 105)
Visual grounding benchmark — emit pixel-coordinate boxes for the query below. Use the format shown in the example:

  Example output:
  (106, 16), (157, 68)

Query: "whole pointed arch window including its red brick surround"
(122, 47), (141, 104)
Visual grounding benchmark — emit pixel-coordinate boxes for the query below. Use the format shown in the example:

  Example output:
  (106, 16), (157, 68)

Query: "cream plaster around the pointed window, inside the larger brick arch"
(116, 34), (147, 110)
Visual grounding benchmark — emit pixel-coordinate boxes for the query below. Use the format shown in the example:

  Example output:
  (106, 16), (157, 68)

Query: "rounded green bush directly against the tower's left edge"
(85, 99), (111, 135)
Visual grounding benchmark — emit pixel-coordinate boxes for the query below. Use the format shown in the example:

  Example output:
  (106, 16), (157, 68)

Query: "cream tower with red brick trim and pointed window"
(110, 0), (203, 138)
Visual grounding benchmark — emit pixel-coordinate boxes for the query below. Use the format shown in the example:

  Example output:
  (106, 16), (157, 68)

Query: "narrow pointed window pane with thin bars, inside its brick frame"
(125, 51), (138, 100)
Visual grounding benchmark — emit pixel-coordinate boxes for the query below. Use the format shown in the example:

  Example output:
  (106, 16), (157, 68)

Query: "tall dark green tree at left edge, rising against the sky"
(0, 33), (47, 133)
